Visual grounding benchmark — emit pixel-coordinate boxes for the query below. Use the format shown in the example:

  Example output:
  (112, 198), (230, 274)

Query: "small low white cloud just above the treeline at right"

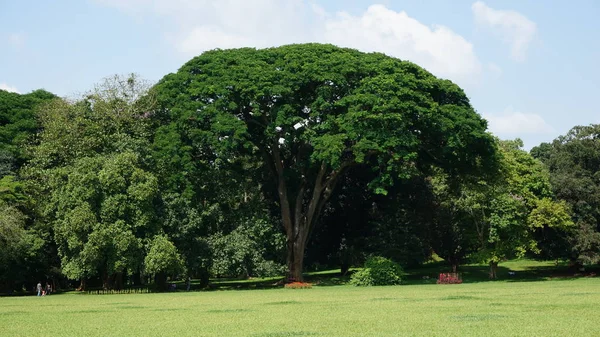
(483, 108), (555, 136)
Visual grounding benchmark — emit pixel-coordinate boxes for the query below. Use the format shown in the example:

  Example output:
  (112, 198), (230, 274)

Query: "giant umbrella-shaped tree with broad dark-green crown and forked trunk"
(156, 44), (495, 280)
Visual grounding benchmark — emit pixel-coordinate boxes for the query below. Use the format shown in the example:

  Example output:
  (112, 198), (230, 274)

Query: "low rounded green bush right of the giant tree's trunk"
(350, 256), (404, 287)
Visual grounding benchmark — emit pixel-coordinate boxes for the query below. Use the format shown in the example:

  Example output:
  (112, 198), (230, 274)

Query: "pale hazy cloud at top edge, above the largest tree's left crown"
(95, 0), (316, 57)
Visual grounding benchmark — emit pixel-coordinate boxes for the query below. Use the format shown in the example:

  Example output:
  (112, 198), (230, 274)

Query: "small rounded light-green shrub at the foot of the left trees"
(144, 235), (185, 276)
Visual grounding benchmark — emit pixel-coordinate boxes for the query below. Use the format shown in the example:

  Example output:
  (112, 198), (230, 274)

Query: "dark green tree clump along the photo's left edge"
(0, 90), (56, 291)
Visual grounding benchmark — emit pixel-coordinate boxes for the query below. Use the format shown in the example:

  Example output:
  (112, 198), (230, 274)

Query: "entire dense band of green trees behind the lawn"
(0, 44), (600, 291)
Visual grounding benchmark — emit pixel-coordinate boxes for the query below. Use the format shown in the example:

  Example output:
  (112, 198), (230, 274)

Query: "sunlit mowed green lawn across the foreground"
(0, 278), (600, 337)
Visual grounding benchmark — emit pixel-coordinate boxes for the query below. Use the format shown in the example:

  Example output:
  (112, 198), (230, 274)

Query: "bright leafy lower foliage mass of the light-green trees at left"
(45, 152), (158, 279)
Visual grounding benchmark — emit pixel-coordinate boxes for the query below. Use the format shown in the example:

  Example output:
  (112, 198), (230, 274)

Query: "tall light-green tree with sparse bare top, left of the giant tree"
(26, 75), (160, 287)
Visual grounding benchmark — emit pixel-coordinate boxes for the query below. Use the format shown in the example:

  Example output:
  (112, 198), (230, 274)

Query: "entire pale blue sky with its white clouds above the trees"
(0, 0), (600, 148)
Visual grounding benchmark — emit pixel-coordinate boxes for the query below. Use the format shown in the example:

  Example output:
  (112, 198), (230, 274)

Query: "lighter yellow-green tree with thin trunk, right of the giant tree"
(457, 139), (572, 278)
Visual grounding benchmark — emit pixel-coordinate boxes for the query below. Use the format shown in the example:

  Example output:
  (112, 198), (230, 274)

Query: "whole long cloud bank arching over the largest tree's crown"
(95, 0), (482, 83)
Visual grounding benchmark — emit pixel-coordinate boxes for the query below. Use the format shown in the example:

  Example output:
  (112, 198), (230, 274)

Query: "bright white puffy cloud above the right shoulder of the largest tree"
(324, 5), (481, 81)
